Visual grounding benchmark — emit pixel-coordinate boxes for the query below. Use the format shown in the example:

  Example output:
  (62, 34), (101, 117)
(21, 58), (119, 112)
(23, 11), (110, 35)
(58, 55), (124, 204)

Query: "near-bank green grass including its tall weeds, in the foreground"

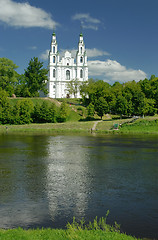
(0, 215), (141, 240)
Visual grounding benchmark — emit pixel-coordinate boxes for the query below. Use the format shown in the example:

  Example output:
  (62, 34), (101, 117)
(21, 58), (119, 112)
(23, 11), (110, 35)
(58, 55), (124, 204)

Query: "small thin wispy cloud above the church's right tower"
(72, 13), (101, 30)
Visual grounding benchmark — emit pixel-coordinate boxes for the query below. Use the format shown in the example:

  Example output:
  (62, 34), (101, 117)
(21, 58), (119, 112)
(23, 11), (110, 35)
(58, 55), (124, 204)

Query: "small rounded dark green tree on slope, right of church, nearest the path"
(95, 97), (109, 119)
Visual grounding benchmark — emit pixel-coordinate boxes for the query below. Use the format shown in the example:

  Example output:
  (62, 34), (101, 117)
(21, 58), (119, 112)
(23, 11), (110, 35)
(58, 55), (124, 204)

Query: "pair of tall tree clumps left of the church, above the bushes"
(0, 57), (48, 97)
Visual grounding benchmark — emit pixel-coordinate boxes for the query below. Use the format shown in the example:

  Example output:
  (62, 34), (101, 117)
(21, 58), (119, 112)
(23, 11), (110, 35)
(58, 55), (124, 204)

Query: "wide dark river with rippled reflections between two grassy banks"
(0, 134), (158, 238)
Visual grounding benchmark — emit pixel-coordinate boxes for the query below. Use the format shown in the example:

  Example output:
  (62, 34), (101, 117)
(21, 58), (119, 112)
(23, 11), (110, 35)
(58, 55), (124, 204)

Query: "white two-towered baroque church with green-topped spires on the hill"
(47, 33), (88, 98)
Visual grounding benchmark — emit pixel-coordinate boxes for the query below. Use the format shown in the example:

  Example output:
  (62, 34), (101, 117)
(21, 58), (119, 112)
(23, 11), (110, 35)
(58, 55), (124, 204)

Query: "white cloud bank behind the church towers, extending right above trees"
(40, 48), (147, 84)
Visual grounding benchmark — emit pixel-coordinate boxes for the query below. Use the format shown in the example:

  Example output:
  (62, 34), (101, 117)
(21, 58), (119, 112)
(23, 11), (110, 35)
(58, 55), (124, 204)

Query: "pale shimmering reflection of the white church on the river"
(47, 136), (90, 223)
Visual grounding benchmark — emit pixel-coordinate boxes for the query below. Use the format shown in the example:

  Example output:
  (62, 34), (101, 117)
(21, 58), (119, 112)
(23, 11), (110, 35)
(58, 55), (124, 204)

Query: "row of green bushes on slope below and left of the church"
(0, 88), (69, 124)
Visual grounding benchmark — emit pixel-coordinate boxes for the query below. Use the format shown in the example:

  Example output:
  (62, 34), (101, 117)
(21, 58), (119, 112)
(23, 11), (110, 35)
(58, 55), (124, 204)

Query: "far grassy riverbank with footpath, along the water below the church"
(0, 116), (158, 134)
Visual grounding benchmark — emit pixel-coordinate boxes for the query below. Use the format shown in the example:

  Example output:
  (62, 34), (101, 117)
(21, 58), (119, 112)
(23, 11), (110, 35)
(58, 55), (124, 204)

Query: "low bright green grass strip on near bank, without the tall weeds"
(0, 228), (141, 240)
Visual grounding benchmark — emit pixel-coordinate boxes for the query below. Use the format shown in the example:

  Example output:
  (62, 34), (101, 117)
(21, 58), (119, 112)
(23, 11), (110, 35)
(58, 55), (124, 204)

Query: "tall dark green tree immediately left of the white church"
(24, 57), (48, 97)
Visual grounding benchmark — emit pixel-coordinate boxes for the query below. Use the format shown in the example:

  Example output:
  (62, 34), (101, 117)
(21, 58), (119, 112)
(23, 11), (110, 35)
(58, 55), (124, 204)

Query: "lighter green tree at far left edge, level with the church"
(0, 58), (19, 96)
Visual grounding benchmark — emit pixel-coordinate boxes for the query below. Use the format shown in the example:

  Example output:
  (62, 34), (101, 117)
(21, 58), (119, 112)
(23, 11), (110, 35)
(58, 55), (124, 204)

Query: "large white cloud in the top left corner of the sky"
(0, 0), (59, 29)
